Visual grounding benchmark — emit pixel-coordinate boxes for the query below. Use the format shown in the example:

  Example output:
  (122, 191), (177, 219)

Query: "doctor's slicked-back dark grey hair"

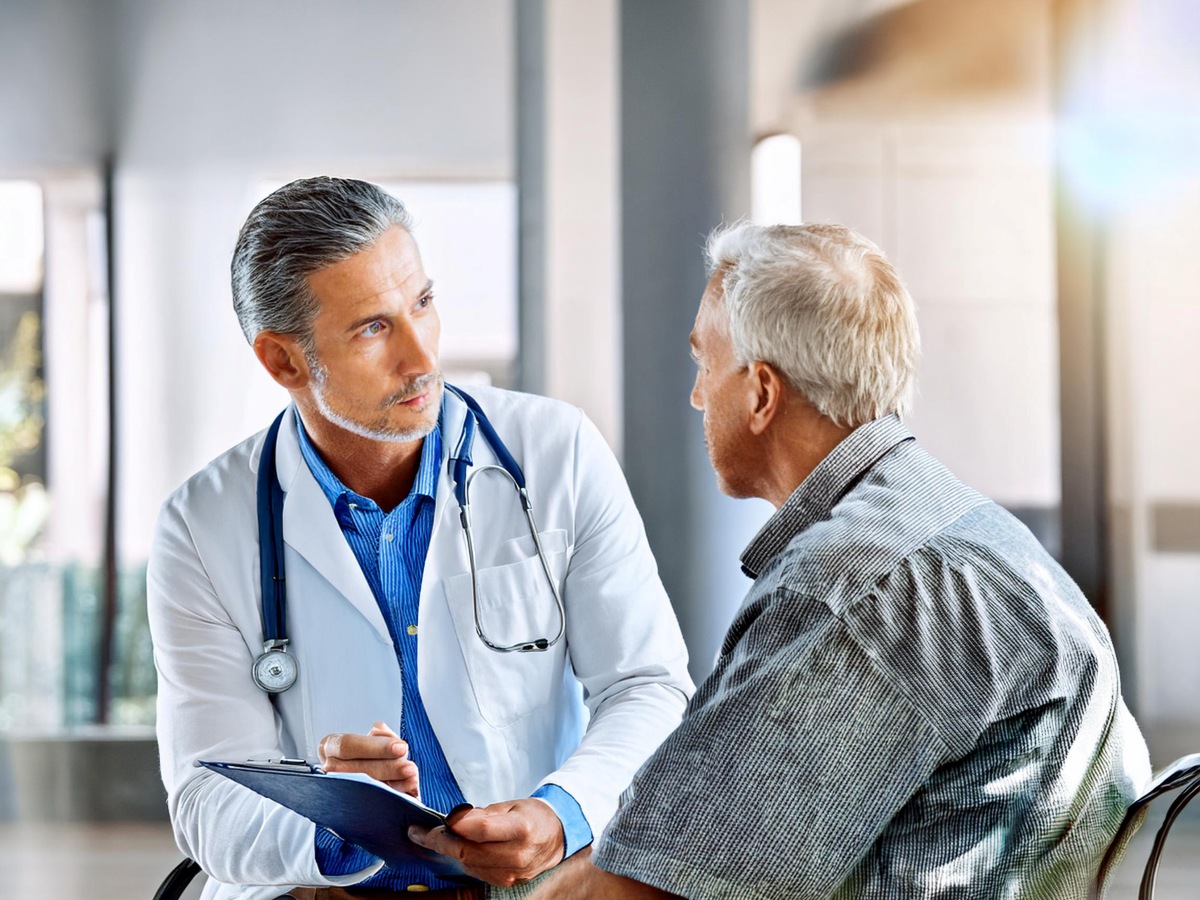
(229, 176), (413, 355)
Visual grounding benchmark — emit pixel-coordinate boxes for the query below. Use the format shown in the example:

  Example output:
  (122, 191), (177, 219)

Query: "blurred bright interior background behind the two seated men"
(0, 0), (1200, 898)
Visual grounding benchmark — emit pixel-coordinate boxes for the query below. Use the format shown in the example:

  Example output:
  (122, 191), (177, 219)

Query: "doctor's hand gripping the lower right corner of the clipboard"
(408, 797), (564, 887)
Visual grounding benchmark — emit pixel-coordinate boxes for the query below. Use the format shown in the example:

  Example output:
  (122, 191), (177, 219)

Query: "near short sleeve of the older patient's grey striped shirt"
(595, 596), (946, 900)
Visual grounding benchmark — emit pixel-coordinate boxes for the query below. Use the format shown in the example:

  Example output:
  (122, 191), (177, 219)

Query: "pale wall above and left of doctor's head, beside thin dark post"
(105, 0), (514, 560)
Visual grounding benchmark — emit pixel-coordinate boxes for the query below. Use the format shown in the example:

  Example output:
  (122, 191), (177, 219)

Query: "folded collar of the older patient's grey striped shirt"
(742, 414), (913, 578)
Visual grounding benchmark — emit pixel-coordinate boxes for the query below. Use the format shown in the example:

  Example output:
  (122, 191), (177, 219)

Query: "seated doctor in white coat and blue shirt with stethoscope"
(148, 178), (692, 900)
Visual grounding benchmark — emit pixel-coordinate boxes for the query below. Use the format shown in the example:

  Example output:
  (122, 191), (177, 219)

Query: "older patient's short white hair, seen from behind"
(708, 222), (920, 427)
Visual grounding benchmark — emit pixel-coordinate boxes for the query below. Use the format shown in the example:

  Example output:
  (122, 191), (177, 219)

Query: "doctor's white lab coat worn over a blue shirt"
(149, 389), (692, 899)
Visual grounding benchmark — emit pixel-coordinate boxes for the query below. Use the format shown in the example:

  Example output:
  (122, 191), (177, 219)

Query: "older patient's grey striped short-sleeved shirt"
(595, 416), (1150, 900)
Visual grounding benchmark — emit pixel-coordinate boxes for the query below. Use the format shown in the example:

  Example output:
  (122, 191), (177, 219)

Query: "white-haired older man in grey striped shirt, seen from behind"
(421, 224), (1150, 900)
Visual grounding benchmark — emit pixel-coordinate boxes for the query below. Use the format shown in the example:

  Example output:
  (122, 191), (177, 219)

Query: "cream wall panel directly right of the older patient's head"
(803, 121), (1060, 509)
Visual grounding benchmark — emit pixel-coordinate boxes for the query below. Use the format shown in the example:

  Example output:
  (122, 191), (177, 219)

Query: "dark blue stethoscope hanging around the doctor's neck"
(251, 384), (566, 694)
